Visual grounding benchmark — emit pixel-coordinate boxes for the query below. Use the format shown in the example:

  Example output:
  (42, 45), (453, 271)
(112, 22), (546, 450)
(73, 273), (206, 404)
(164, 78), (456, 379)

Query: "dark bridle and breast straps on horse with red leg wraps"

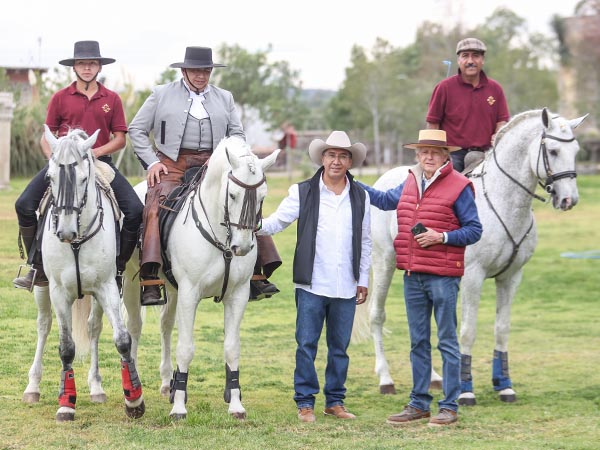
(50, 155), (104, 299)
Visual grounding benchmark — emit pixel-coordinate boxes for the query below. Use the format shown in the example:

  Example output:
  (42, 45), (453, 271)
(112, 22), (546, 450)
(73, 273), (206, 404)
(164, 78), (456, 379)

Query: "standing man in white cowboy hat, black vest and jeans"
(258, 131), (371, 422)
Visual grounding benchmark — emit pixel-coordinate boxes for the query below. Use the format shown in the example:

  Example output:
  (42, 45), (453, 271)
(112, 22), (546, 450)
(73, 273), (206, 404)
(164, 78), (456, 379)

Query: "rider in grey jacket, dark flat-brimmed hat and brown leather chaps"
(129, 47), (281, 306)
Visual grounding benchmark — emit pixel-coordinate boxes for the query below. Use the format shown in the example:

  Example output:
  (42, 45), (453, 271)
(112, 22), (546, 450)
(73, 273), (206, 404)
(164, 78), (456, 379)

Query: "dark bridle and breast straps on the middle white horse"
(190, 165), (267, 302)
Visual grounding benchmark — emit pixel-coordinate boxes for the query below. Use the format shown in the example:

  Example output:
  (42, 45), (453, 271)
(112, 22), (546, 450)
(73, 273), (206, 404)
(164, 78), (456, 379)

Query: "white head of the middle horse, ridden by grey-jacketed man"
(209, 136), (279, 256)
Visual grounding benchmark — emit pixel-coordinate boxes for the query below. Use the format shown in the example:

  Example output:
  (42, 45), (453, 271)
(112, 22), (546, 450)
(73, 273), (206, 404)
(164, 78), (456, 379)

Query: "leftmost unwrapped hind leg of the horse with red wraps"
(23, 286), (52, 403)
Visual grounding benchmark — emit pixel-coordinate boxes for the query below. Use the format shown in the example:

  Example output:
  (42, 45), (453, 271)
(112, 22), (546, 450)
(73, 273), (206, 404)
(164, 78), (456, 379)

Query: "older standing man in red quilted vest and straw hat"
(362, 130), (482, 426)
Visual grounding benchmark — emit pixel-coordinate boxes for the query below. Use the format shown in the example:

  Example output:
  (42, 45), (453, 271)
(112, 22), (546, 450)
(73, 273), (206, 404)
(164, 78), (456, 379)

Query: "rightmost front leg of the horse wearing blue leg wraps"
(492, 270), (523, 403)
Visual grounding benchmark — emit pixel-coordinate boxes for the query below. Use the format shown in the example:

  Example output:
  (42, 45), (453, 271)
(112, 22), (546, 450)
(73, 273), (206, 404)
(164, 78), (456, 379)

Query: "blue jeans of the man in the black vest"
(294, 289), (356, 408)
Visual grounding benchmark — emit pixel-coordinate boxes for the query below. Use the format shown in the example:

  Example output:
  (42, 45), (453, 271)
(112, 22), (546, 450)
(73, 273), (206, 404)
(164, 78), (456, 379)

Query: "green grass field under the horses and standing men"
(0, 175), (600, 449)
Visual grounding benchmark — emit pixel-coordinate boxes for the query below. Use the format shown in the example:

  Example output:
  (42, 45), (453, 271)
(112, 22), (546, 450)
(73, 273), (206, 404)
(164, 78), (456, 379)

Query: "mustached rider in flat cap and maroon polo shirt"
(425, 37), (510, 172)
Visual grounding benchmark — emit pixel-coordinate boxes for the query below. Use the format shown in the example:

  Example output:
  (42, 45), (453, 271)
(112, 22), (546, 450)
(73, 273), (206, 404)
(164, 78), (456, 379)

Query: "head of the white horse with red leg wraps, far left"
(44, 125), (100, 242)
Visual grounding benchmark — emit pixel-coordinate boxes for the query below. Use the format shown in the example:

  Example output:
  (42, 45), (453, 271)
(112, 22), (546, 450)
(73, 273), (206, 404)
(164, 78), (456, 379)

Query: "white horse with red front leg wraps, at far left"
(23, 127), (145, 421)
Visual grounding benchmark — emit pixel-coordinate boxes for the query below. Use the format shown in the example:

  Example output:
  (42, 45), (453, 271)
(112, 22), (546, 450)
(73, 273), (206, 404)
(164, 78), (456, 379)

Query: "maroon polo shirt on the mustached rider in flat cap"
(426, 71), (510, 148)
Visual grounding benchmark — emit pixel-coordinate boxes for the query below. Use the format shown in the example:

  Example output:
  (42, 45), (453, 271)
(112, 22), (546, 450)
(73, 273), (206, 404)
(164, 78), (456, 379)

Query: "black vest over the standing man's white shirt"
(294, 167), (366, 285)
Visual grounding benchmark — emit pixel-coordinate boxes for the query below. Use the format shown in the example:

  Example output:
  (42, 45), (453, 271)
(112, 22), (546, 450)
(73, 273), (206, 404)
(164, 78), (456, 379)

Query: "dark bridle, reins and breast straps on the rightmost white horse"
(480, 130), (577, 278)
